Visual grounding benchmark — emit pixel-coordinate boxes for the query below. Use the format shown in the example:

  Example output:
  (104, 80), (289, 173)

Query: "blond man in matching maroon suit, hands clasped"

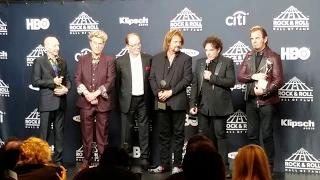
(74, 30), (115, 171)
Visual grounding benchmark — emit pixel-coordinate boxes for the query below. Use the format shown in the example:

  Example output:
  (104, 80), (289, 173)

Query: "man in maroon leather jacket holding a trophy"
(238, 26), (284, 172)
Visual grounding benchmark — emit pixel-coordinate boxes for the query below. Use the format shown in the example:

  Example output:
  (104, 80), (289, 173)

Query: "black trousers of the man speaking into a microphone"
(198, 113), (229, 170)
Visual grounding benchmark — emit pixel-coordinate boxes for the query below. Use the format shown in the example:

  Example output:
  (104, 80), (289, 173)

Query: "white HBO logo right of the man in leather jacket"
(281, 47), (311, 60)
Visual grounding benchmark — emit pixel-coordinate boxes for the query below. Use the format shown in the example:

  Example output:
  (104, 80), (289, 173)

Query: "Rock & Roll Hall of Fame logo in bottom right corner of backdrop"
(285, 148), (320, 174)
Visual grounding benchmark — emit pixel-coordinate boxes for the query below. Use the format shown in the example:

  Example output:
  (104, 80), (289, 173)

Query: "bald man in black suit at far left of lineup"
(31, 37), (71, 165)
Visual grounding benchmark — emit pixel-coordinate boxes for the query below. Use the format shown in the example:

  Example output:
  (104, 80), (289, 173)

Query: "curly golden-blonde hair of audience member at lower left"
(17, 137), (51, 166)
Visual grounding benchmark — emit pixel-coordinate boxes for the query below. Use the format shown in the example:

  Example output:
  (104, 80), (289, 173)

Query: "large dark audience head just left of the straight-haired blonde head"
(182, 140), (226, 180)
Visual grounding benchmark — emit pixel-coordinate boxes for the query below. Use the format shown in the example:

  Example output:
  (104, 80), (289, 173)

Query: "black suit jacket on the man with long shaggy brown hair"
(149, 52), (192, 110)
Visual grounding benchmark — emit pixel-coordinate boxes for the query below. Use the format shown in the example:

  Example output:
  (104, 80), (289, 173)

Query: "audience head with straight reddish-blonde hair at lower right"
(233, 145), (271, 180)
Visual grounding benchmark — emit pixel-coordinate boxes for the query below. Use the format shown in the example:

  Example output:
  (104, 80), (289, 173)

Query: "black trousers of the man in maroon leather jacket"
(246, 99), (277, 170)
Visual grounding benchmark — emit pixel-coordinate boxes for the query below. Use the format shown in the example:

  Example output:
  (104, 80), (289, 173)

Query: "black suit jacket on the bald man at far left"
(31, 55), (71, 112)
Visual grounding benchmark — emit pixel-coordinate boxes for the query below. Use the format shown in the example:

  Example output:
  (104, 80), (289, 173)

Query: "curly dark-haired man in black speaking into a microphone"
(190, 36), (236, 177)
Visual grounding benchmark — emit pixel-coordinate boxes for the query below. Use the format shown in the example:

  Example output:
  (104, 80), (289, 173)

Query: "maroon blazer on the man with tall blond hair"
(74, 53), (116, 112)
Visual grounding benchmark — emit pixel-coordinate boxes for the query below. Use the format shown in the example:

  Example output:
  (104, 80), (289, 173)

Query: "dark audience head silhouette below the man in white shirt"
(99, 146), (130, 168)
